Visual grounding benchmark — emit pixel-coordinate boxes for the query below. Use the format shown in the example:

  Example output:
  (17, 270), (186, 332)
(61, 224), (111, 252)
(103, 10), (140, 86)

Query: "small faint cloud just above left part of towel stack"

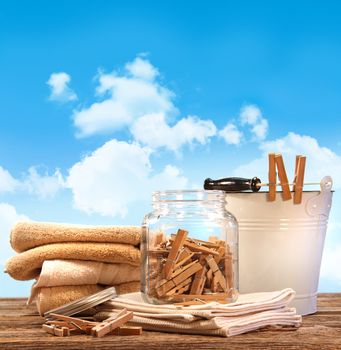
(22, 166), (65, 199)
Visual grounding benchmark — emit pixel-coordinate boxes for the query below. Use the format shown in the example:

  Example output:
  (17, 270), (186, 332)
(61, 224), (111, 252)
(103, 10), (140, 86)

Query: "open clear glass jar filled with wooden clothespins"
(141, 190), (238, 305)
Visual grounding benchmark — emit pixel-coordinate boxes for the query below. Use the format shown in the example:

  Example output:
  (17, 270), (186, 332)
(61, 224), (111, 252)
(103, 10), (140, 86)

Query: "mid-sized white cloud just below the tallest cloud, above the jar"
(131, 113), (216, 151)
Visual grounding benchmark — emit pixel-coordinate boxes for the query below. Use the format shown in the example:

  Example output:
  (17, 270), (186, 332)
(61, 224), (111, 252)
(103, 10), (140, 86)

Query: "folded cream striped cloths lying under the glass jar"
(95, 288), (302, 337)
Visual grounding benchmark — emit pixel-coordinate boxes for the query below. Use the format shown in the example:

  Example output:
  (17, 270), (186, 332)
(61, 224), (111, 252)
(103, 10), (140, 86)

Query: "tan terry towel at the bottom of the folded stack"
(36, 282), (140, 315)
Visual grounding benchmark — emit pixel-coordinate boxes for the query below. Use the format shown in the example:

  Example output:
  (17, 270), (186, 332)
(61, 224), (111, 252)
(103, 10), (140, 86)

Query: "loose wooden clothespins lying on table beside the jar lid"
(42, 309), (142, 337)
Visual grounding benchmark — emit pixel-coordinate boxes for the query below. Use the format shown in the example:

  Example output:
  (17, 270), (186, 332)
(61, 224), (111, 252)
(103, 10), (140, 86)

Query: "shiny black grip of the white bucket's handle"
(204, 177), (261, 192)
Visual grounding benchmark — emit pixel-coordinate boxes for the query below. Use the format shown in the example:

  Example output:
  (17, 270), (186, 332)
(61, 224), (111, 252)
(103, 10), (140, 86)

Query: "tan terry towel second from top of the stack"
(5, 242), (140, 280)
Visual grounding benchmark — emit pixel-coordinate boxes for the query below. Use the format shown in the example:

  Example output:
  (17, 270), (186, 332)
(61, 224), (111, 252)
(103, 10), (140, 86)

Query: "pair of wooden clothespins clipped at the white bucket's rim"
(268, 153), (306, 204)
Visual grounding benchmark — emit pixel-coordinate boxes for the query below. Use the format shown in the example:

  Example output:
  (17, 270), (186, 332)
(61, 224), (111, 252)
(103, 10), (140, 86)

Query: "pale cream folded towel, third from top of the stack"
(34, 260), (140, 288)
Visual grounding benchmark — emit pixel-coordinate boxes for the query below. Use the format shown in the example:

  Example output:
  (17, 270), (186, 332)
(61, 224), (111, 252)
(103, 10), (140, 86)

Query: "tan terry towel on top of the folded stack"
(11, 222), (141, 253)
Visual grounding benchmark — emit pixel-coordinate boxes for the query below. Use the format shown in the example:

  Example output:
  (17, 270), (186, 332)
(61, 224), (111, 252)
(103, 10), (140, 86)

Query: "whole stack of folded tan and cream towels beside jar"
(5, 222), (141, 315)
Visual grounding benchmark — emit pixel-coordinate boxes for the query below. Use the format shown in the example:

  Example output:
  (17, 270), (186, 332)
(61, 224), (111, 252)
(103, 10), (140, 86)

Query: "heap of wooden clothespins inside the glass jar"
(148, 229), (234, 305)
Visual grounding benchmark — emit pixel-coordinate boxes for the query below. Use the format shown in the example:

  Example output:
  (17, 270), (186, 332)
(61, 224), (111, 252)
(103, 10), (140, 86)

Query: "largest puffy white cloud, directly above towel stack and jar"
(67, 139), (187, 217)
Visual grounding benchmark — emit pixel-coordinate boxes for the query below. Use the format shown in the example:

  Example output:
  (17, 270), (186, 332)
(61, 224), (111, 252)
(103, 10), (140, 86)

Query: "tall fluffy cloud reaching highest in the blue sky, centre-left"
(73, 57), (176, 137)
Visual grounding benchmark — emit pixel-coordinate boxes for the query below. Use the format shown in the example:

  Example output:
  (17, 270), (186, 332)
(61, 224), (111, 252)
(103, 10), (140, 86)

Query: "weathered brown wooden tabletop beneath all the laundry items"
(0, 293), (341, 350)
